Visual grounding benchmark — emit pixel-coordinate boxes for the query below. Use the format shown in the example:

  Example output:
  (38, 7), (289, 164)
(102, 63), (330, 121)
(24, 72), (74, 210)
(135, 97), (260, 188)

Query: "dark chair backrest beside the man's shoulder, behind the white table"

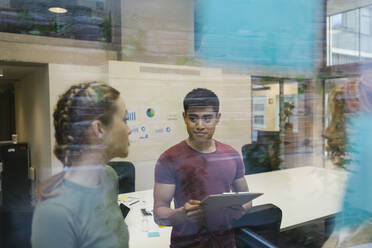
(242, 144), (271, 175)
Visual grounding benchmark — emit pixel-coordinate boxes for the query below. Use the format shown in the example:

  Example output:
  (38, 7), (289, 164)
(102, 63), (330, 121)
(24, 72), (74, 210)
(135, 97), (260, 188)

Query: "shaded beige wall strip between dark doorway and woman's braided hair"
(15, 66), (51, 179)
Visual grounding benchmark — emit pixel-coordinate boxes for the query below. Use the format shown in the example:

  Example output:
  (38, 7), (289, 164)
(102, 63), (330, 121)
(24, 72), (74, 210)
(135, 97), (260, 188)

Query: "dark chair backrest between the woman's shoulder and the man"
(108, 161), (136, 194)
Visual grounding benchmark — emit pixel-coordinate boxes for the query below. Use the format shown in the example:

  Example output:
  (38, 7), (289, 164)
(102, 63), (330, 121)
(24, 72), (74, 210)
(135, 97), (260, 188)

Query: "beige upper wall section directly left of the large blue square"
(121, 0), (194, 64)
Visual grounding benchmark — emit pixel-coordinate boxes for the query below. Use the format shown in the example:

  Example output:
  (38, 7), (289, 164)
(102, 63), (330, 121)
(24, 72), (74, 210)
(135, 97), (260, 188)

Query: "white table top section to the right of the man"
(245, 167), (347, 231)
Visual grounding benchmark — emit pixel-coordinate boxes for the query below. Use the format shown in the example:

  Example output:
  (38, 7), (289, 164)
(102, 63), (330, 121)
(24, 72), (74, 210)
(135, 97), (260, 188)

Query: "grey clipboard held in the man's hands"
(201, 192), (263, 211)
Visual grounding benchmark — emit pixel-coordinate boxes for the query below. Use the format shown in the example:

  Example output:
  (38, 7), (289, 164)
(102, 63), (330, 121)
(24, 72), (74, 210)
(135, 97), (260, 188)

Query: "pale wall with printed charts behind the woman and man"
(17, 61), (251, 190)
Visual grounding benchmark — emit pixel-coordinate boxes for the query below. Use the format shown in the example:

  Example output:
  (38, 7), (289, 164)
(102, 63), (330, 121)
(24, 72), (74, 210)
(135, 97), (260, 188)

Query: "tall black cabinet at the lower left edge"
(0, 143), (33, 247)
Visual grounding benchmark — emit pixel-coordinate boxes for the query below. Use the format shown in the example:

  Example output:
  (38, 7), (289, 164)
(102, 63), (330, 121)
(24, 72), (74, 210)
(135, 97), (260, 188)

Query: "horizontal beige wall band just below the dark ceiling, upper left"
(0, 32), (116, 65)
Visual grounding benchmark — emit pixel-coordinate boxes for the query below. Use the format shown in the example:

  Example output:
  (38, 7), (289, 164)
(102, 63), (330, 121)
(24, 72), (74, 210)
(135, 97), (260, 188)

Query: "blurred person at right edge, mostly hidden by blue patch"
(323, 74), (372, 248)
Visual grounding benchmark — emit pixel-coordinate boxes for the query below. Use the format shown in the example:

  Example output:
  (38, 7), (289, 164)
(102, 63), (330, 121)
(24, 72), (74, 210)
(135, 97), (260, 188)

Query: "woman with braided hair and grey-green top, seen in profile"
(31, 82), (130, 248)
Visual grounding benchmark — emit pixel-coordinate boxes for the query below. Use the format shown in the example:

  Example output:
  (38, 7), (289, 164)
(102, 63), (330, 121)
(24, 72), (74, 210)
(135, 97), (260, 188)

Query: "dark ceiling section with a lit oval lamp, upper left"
(0, 0), (113, 42)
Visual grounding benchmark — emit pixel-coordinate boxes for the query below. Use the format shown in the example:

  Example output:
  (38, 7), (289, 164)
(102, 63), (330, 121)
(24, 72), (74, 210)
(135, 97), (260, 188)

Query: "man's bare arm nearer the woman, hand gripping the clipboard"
(154, 183), (201, 226)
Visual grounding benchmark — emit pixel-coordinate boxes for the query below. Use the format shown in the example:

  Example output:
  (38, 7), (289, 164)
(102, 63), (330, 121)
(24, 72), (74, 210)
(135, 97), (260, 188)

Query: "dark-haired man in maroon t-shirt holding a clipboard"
(154, 88), (251, 247)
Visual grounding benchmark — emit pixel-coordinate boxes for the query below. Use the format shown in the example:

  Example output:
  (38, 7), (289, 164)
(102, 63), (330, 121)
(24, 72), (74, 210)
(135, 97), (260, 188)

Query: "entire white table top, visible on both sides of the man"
(120, 167), (347, 247)
